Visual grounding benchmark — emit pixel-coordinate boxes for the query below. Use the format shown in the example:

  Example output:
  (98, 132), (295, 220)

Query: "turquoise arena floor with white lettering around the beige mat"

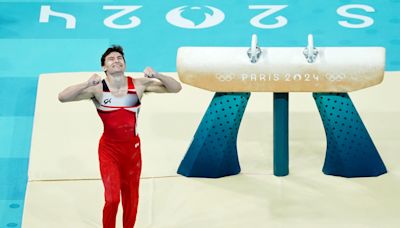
(0, 0), (400, 227)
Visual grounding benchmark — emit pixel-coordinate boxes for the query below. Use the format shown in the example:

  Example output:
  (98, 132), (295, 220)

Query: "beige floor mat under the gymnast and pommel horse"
(23, 73), (400, 228)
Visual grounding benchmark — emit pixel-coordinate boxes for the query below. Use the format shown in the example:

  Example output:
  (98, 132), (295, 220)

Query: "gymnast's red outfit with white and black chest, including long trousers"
(97, 77), (142, 228)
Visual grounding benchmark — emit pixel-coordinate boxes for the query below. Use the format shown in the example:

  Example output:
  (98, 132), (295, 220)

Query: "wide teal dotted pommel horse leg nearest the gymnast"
(178, 93), (250, 178)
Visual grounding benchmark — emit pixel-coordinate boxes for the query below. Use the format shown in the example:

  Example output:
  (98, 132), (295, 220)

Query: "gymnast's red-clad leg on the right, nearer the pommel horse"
(121, 141), (142, 228)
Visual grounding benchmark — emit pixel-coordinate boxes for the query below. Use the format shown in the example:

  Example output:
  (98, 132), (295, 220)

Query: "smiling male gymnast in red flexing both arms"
(58, 45), (182, 228)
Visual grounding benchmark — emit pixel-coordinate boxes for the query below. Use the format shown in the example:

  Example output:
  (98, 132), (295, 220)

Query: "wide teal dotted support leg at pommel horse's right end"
(313, 93), (387, 177)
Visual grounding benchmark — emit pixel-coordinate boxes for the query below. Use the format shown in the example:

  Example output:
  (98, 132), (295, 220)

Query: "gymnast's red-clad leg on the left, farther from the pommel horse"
(99, 139), (121, 228)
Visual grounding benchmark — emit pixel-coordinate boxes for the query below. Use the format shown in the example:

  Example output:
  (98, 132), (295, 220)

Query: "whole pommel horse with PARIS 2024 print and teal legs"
(177, 35), (387, 178)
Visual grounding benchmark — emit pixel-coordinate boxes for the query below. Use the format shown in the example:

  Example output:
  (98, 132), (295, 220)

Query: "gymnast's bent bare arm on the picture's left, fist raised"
(58, 74), (101, 102)
